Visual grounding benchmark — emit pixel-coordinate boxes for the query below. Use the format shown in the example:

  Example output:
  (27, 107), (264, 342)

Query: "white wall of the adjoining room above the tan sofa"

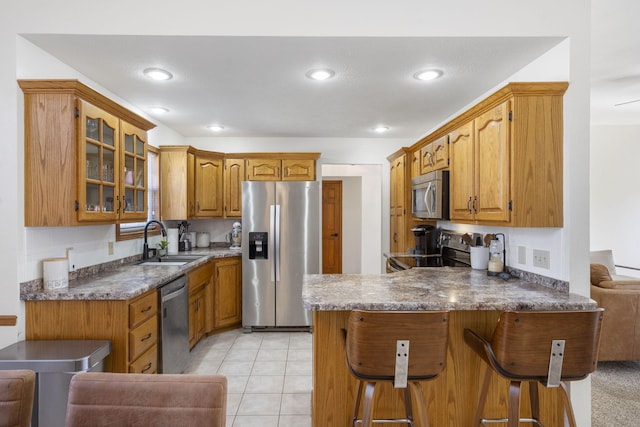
(590, 125), (640, 277)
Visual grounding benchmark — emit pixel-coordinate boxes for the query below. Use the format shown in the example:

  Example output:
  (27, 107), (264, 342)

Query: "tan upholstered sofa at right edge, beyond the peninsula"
(591, 251), (640, 361)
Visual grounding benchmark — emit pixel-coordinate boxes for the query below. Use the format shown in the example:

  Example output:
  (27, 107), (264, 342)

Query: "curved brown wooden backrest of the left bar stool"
(346, 310), (449, 380)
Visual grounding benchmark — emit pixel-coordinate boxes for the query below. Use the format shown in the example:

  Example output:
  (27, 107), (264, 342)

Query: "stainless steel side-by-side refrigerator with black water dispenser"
(242, 181), (321, 332)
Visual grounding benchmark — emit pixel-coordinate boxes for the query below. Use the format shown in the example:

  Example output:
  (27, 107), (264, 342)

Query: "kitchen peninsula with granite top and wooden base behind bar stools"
(303, 267), (596, 427)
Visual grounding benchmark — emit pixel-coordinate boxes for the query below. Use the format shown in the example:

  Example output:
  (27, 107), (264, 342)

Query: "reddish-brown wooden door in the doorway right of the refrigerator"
(322, 181), (342, 274)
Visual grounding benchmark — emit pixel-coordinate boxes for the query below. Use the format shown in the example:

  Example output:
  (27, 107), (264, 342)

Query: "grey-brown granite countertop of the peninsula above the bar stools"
(302, 267), (597, 311)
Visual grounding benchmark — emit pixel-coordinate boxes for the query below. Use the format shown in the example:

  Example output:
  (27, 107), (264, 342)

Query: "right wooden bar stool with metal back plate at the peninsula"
(464, 308), (604, 427)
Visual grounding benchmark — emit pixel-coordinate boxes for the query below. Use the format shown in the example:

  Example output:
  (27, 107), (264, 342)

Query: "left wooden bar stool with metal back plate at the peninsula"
(345, 310), (449, 427)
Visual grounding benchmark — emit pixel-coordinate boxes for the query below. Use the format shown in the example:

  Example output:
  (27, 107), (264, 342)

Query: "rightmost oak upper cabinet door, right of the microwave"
(474, 101), (509, 221)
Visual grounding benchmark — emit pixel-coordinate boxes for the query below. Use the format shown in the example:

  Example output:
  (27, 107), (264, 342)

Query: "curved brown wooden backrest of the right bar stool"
(491, 309), (603, 381)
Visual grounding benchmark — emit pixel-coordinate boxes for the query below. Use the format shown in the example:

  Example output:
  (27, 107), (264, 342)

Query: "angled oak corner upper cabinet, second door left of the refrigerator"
(195, 152), (224, 218)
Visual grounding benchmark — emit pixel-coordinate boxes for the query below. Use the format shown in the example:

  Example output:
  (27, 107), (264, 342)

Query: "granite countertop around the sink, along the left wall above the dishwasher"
(20, 247), (241, 301)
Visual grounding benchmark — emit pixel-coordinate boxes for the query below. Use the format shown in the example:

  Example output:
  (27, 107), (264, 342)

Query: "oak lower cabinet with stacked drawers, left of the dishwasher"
(25, 289), (158, 373)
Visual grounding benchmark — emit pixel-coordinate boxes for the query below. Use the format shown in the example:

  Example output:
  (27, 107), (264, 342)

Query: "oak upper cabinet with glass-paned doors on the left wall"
(18, 80), (154, 227)
